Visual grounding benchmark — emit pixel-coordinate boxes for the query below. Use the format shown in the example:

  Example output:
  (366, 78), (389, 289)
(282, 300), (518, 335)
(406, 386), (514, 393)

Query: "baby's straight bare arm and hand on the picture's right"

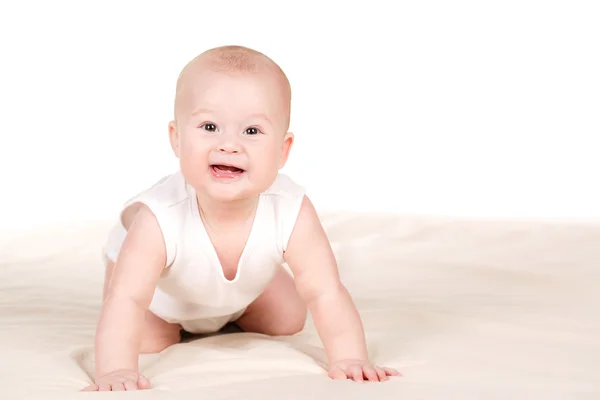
(285, 197), (400, 381)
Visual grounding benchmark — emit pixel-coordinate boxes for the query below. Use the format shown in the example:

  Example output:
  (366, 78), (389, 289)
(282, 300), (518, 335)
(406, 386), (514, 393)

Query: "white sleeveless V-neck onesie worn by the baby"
(104, 171), (305, 333)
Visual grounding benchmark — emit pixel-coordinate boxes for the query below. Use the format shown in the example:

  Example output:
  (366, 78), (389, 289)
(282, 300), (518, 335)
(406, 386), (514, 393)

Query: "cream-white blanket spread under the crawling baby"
(0, 213), (600, 400)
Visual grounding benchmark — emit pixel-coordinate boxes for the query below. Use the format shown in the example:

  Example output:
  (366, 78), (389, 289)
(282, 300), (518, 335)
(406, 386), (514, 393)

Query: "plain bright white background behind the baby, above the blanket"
(0, 1), (600, 232)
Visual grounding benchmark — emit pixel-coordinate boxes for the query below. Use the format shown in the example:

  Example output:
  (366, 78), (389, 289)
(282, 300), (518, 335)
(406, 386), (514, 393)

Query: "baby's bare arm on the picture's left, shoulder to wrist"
(89, 207), (166, 390)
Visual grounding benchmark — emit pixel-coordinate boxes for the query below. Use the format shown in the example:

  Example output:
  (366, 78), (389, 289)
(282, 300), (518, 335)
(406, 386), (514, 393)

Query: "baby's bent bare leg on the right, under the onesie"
(236, 267), (307, 336)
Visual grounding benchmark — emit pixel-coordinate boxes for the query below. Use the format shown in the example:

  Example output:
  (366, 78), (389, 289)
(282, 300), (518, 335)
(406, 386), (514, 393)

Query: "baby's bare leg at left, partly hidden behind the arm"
(102, 260), (181, 353)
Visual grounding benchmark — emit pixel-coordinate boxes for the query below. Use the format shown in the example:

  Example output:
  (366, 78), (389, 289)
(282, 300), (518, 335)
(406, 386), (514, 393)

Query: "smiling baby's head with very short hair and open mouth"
(169, 46), (293, 201)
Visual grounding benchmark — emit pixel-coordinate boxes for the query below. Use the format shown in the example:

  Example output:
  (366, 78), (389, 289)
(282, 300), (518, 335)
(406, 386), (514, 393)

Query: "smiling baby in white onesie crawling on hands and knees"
(83, 46), (400, 391)
